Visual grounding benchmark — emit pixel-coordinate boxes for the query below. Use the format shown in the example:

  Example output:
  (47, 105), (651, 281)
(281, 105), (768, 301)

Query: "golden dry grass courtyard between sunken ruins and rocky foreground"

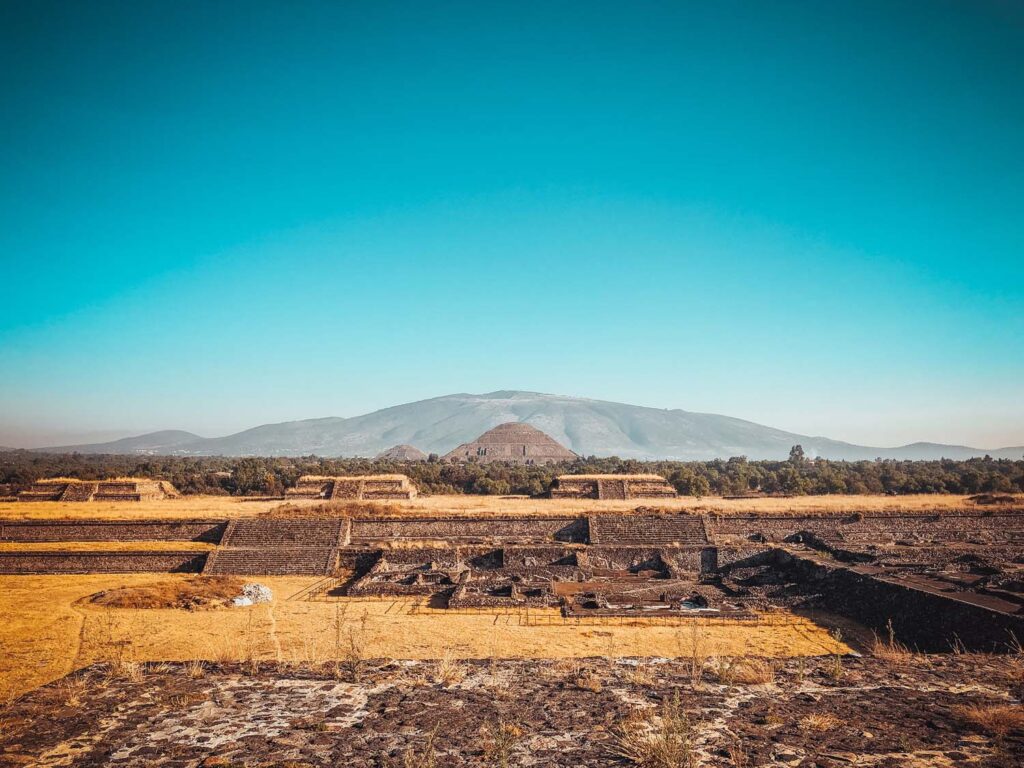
(0, 573), (848, 693)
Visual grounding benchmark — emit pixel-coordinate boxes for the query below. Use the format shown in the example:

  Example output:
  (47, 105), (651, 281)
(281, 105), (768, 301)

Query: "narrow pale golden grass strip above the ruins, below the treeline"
(0, 495), (1024, 519)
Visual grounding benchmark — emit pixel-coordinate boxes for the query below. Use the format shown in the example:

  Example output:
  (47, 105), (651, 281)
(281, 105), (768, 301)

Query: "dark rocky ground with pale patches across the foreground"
(0, 654), (1024, 768)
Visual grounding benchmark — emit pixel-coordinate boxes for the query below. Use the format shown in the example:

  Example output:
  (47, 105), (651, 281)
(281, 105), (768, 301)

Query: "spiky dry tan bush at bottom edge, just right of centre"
(611, 691), (697, 768)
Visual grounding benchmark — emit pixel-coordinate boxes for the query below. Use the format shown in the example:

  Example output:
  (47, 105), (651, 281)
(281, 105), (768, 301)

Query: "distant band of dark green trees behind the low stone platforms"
(0, 445), (1024, 496)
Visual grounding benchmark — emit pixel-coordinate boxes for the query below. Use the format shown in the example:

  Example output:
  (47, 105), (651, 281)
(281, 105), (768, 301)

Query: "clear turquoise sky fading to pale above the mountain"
(0, 0), (1024, 447)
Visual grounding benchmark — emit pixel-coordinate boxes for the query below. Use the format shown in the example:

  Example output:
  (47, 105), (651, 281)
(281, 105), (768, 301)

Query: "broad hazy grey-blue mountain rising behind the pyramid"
(32, 391), (1024, 461)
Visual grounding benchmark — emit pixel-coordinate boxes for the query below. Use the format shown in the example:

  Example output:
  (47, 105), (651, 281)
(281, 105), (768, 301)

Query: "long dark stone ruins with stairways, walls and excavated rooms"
(6, 511), (1024, 650)
